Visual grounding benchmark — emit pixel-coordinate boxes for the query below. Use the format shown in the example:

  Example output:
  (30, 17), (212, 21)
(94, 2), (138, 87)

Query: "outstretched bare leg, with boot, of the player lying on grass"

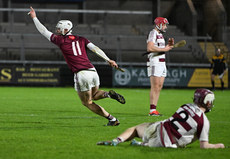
(97, 123), (150, 146)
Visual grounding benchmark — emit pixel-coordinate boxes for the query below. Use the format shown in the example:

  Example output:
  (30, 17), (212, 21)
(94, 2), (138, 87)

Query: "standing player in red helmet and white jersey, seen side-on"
(147, 17), (174, 116)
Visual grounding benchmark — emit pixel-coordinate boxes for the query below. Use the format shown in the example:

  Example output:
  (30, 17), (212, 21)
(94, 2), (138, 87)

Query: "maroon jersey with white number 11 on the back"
(50, 34), (94, 72)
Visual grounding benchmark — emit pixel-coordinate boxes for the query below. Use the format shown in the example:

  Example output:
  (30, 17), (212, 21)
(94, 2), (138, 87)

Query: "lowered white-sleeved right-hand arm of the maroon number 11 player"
(87, 43), (118, 68)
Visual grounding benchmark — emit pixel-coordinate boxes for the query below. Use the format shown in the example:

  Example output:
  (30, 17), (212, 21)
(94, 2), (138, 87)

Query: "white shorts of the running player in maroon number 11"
(74, 69), (100, 92)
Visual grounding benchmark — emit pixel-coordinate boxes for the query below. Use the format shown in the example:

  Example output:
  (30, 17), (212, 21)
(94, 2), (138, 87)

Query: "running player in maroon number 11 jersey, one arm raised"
(28, 7), (125, 126)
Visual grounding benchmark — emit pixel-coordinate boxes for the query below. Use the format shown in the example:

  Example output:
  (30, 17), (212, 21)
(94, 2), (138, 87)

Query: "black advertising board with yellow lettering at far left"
(0, 66), (60, 85)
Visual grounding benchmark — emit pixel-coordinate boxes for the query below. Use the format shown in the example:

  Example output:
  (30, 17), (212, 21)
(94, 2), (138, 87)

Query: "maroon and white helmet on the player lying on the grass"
(193, 88), (215, 113)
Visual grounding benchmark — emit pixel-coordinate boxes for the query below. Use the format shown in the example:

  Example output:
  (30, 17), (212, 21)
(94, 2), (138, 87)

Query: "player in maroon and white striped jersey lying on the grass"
(97, 89), (225, 148)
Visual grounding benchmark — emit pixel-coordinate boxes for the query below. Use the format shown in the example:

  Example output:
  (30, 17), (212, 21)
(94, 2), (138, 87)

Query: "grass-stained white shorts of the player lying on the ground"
(142, 122), (164, 147)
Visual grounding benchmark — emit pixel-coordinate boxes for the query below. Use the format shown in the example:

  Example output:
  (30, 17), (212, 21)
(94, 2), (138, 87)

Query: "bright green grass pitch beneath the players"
(0, 87), (230, 159)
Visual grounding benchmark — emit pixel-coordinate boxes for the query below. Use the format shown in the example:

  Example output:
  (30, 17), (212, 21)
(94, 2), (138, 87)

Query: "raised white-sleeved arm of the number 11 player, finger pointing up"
(28, 7), (53, 41)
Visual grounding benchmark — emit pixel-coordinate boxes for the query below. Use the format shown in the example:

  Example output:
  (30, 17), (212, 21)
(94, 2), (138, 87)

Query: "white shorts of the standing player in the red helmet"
(147, 65), (167, 77)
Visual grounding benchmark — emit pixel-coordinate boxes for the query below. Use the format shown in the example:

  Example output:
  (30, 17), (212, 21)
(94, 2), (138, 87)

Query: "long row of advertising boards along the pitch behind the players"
(0, 64), (230, 88)
